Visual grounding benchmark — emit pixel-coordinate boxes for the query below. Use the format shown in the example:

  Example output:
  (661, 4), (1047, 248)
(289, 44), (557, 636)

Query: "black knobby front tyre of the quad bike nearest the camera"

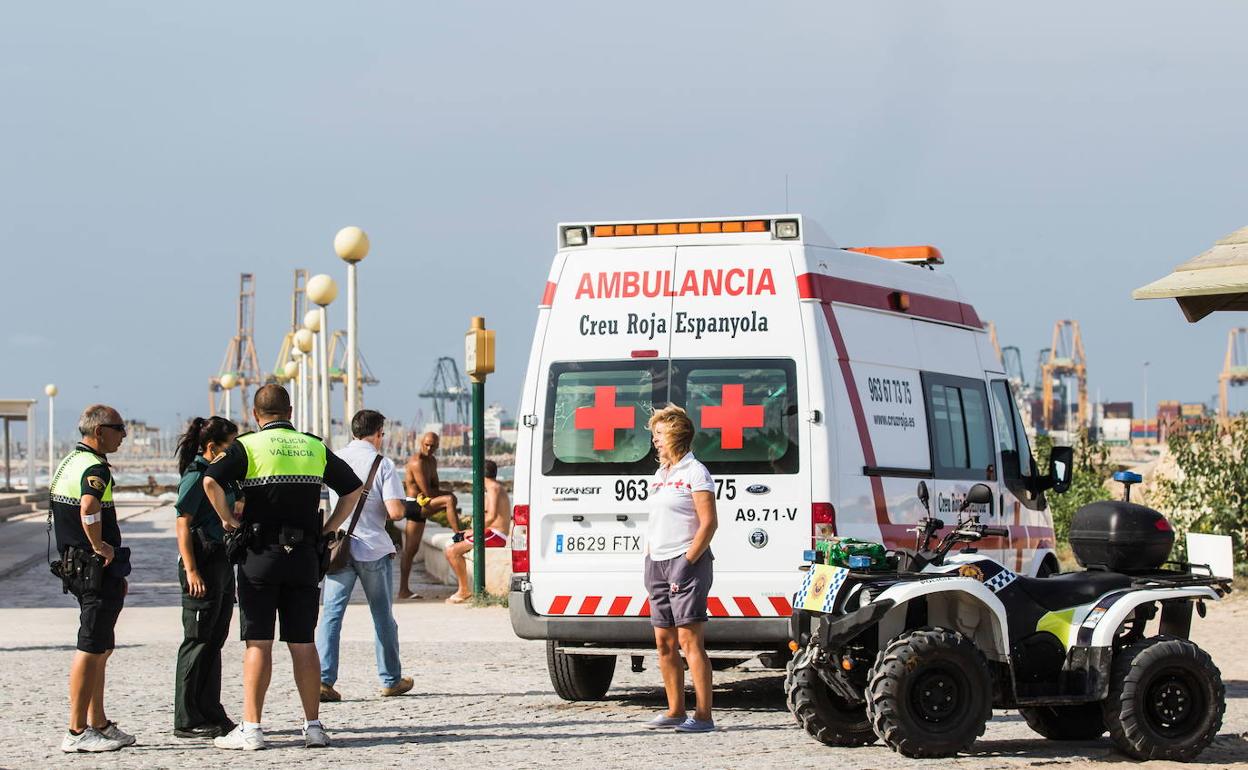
(866, 628), (992, 758)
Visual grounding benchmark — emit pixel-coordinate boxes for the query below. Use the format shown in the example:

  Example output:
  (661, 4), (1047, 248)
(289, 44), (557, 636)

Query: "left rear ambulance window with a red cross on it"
(542, 361), (666, 475)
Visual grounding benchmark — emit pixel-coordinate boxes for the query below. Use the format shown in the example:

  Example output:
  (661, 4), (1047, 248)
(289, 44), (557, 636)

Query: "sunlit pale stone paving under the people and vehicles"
(0, 508), (1248, 769)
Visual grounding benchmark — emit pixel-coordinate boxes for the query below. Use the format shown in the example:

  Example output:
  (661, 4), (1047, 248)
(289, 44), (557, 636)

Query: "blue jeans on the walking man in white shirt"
(316, 557), (403, 688)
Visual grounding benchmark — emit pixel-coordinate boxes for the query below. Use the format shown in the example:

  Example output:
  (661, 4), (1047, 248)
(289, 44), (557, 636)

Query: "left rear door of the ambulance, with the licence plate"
(529, 246), (676, 616)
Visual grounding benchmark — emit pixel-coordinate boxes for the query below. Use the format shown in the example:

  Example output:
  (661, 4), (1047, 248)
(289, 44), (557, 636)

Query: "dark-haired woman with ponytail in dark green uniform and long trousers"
(173, 417), (241, 738)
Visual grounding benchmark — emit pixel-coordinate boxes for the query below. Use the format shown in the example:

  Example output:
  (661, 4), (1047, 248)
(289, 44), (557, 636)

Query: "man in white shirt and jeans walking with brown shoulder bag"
(316, 409), (413, 703)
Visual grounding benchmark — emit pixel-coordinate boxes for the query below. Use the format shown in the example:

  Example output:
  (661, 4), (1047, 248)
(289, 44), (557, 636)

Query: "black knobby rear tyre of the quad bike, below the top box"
(1102, 636), (1227, 763)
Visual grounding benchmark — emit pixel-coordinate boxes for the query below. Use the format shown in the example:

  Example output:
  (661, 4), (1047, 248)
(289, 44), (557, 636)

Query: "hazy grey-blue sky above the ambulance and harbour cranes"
(0, 1), (1248, 439)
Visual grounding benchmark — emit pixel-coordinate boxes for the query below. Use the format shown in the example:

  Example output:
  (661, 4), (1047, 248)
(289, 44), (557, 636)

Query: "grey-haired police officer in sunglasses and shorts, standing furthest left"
(50, 404), (135, 753)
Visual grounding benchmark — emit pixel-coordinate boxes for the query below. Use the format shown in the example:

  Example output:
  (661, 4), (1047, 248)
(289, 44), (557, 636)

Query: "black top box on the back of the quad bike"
(1070, 500), (1174, 574)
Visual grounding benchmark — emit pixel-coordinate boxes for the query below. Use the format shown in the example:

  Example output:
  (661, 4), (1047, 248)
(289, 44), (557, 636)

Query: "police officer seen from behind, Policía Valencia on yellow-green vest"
(203, 384), (363, 750)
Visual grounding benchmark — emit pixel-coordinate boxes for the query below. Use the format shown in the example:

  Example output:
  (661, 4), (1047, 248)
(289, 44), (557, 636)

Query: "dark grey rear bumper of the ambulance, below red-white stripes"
(508, 587), (789, 646)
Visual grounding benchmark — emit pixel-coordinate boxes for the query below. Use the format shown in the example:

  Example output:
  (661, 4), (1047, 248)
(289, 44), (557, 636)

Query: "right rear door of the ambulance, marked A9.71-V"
(671, 243), (811, 616)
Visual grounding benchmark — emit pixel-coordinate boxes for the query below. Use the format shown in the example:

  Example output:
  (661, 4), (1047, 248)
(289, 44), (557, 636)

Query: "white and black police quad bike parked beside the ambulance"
(785, 474), (1231, 761)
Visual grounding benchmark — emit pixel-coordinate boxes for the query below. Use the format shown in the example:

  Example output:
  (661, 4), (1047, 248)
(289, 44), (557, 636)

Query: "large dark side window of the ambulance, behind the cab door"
(922, 372), (996, 480)
